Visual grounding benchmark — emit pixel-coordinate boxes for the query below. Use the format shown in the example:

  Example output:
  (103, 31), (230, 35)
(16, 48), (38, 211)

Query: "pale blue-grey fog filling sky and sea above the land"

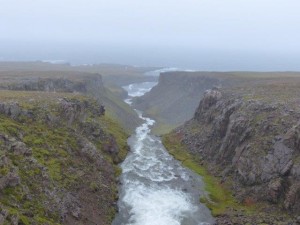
(0, 0), (300, 70)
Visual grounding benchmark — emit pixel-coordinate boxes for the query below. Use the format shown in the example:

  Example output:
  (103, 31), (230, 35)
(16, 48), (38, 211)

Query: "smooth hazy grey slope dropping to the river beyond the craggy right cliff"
(134, 72), (232, 133)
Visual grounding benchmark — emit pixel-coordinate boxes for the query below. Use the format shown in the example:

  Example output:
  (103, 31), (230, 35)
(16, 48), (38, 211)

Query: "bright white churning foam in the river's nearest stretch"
(123, 184), (195, 225)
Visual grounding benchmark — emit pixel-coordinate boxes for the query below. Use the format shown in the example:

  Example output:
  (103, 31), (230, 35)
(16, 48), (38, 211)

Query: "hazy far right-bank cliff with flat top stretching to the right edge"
(134, 71), (300, 134)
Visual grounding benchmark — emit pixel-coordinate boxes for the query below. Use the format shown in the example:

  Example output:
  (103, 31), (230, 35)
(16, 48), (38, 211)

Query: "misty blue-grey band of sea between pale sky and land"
(0, 43), (300, 71)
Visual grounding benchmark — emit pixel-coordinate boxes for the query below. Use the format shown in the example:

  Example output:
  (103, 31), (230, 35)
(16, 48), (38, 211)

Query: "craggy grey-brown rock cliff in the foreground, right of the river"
(173, 84), (300, 218)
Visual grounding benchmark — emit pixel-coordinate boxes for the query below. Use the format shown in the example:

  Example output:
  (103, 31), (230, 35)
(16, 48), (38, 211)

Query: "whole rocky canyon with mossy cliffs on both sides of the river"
(0, 63), (300, 225)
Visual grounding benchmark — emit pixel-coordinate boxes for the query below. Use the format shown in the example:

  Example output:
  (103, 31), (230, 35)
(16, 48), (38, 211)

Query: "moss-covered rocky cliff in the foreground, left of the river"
(0, 91), (127, 225)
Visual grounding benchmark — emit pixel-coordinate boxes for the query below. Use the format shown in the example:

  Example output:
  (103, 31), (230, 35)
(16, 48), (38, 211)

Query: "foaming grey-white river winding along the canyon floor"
(112, 82), (214, 225)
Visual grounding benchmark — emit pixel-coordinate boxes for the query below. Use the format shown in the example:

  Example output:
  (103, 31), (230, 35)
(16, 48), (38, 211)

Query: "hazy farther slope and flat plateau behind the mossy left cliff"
(0, 71), (141, 132)
